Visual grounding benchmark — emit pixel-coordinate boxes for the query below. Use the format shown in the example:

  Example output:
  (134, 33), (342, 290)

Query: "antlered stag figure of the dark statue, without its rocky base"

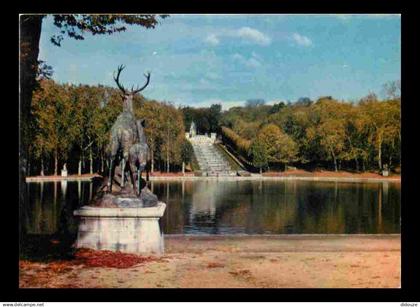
(108, 65), (150, 194)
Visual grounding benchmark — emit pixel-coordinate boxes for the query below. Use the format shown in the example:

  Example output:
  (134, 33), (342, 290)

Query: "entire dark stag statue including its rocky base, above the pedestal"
(96, 65), (157, 207)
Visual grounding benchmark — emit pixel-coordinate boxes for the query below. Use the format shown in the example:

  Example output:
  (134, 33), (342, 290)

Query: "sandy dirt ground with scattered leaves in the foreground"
(19, 235), (401, 288)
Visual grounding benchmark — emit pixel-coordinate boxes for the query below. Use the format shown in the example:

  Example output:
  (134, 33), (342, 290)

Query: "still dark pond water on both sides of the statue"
(24, 180), (401, 240)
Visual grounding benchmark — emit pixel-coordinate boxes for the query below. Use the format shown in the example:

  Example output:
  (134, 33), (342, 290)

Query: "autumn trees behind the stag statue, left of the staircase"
(27, 79), (192, 175)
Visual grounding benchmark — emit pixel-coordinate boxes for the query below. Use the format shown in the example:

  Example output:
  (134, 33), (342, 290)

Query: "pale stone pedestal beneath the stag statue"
(74, 202), (166, 254)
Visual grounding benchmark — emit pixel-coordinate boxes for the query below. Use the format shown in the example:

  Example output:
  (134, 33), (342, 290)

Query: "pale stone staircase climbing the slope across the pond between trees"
(190, 135), (236, 176)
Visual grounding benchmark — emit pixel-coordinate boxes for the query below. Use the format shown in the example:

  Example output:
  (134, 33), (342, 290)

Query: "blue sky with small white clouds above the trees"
(39, 15), (401, 109)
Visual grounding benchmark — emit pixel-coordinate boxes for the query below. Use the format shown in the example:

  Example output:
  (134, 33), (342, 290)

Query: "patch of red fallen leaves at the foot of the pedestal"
(75, 248), (157, 269)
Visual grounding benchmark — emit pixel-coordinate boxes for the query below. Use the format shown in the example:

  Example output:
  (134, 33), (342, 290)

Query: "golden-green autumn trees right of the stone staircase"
(220, 94), (401, 171)
